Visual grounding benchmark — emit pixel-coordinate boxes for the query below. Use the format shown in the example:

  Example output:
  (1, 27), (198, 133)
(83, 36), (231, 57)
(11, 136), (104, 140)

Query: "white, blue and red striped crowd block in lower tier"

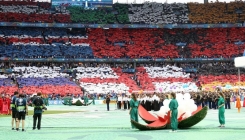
(13, 66), (81, 95)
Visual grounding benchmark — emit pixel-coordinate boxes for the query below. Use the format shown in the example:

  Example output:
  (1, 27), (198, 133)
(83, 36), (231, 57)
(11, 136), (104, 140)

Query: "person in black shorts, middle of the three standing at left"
(15, 94), (28, 131)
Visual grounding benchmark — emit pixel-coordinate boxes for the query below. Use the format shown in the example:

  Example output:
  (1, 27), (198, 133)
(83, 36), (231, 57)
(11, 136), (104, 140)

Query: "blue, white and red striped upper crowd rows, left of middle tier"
(0, 27), (87, 44)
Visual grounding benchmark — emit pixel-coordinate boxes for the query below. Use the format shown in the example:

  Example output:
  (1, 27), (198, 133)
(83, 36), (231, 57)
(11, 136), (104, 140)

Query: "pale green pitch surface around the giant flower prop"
(0, 103), (245, 140)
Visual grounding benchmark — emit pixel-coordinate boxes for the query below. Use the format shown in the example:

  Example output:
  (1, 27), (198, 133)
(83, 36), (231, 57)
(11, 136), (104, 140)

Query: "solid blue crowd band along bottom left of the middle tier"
(0, 44), (94, 58)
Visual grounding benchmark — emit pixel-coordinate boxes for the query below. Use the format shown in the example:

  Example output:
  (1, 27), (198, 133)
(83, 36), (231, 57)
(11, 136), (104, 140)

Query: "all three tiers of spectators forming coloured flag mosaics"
(0, 1), (245, 95)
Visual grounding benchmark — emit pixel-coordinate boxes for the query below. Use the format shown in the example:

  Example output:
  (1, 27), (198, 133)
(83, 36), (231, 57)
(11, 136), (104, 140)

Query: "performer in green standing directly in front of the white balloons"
(169, 93), (179, 132)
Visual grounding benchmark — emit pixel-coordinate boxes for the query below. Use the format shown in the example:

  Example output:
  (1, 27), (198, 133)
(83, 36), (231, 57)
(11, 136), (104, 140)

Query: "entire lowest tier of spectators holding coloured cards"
(0, 62), (245, 96)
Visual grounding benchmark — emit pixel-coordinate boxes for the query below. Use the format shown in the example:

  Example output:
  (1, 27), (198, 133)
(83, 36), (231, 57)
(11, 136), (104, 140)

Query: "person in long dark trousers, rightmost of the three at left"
(32, 93), (47, 130)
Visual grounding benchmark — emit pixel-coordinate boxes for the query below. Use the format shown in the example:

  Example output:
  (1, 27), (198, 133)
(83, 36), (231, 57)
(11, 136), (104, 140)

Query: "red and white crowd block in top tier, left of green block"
(0, 1), (71, 23)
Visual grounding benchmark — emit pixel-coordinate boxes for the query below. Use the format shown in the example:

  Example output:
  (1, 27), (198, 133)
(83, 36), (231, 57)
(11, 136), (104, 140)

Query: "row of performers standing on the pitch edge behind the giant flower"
(120, 92), (245, 111)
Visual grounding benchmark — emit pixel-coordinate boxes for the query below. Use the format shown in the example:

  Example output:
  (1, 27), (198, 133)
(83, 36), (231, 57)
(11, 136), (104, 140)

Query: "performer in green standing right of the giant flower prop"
(218, 92), (225, 127)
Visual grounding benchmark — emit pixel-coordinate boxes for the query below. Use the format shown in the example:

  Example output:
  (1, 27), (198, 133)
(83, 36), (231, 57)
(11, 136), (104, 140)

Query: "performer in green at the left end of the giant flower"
(129, 93), (139, 128)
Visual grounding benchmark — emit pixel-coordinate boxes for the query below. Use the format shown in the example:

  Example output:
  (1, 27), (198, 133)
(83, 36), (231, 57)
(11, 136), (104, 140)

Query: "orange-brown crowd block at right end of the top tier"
(188, 1), (245, 24)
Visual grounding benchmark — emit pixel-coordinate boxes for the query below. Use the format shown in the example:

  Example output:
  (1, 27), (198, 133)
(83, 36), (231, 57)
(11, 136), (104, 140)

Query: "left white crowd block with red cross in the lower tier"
(80, 67), (140, 93)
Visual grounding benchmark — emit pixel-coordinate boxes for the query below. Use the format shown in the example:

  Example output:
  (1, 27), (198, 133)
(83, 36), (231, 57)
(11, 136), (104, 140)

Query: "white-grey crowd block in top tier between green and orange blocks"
(128, 2), (189, 24)
